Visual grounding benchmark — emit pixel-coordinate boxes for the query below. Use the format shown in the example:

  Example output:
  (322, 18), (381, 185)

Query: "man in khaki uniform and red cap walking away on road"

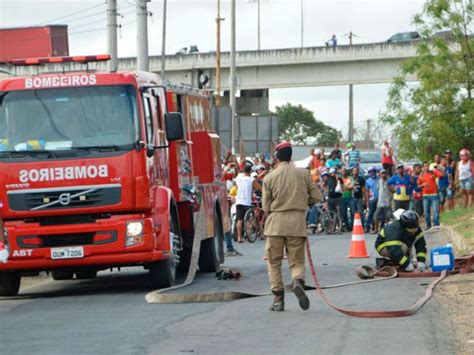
(262, 142), (321, 311)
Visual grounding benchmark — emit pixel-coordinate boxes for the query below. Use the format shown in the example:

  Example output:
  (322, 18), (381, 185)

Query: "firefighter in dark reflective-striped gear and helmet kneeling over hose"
(375, 210), (426, 272)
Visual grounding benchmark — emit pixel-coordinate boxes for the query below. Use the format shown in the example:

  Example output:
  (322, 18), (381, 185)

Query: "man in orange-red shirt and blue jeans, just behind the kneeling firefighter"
(418, 162), (443, 228)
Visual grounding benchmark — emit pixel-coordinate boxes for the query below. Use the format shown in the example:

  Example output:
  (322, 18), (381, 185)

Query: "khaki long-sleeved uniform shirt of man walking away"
(262, 162), (321, 237)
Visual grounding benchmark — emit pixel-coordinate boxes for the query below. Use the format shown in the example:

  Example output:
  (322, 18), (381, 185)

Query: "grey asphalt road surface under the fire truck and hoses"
(0, 234), (455, 355)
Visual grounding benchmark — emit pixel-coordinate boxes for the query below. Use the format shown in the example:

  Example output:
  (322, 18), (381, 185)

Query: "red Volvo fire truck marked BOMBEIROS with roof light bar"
(0, 56), (230, 296)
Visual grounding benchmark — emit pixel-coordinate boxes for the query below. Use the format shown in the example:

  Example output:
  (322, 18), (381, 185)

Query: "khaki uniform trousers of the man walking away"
(265, 236), (306, 291)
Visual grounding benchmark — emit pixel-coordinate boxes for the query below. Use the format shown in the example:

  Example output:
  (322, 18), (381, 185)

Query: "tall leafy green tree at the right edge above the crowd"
(382, 0), (474, 159)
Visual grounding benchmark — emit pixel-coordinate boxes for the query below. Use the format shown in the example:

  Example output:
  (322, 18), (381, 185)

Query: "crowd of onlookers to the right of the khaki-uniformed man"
(308, 145), (474, 234)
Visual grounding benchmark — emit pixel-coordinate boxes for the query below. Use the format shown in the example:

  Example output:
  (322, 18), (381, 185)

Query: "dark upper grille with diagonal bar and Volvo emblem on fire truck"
(8, 184), (122, 211)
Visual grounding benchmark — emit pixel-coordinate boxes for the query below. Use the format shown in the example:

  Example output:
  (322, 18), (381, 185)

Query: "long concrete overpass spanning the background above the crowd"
(0, 43), (416, 90)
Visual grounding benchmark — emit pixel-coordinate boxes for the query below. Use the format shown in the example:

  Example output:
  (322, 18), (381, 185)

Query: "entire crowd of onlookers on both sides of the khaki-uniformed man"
(223, 141), (474, 250)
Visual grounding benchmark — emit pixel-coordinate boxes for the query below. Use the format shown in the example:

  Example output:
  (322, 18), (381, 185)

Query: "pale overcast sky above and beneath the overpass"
(0, 0), (424, 137)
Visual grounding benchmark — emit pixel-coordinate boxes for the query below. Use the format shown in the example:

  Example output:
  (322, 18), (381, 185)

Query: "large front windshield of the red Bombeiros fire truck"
(0, 85), (139, 156)
